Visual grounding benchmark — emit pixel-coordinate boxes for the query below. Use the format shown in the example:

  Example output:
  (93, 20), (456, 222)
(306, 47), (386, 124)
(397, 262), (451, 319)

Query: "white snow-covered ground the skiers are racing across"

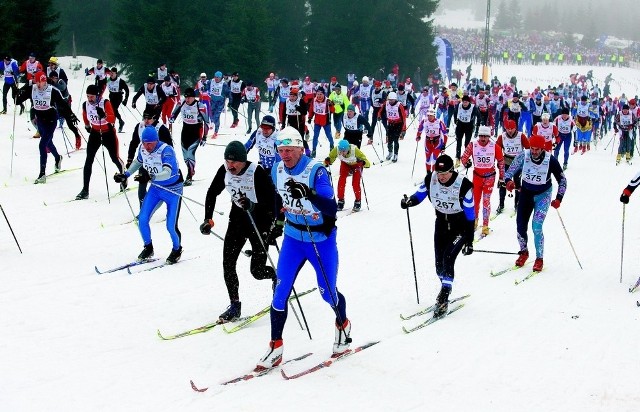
(0, 58), (640, 411)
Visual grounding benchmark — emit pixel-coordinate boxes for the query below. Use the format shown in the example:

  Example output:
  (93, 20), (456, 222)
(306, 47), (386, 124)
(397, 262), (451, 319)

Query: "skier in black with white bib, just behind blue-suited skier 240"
(169, 87), (209, 186)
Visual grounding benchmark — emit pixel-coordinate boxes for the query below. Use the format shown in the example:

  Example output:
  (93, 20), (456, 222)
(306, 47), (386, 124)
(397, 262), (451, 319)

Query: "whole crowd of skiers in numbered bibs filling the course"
(2, 56), (640, 370)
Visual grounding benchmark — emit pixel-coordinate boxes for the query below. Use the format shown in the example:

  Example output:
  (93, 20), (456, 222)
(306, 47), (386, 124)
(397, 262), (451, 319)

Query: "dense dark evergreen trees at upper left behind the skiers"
(8, 0), (438, 90)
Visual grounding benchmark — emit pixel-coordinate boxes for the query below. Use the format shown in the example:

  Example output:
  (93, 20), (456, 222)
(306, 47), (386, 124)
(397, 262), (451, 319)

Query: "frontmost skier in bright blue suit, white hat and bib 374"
(256, 127), (351, 371)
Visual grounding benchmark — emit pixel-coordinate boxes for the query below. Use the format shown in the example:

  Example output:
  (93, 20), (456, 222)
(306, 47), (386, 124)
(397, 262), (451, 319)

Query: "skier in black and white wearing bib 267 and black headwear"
(400, 154), (476, 318)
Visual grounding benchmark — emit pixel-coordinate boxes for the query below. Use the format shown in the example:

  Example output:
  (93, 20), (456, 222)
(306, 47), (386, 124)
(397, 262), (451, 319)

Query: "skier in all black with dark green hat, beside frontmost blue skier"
(200, 141), (276, 323)
